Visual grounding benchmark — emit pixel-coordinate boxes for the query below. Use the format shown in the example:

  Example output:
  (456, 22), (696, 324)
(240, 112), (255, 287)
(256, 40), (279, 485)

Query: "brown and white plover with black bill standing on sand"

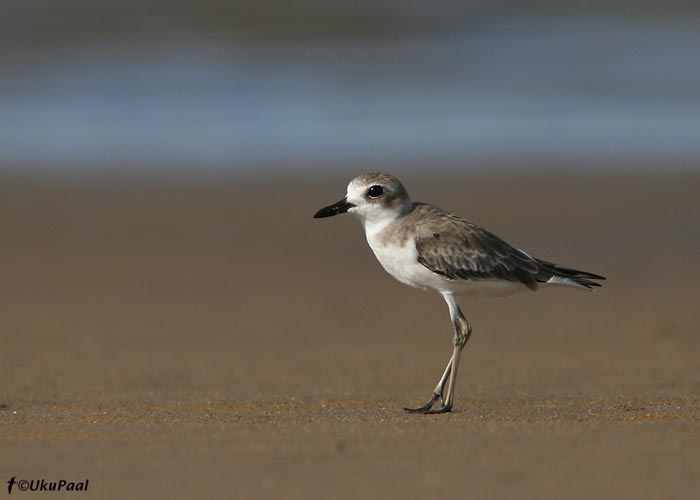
(314, 173), (605, 413)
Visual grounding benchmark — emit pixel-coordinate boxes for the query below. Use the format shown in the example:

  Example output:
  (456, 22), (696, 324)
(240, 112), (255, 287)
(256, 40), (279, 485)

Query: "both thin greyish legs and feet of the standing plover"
(406, 294), (472, 414)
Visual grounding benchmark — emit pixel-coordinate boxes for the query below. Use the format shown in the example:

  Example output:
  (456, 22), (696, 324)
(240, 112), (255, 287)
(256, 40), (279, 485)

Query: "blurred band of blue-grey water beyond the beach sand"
(0, 19), (700, 174)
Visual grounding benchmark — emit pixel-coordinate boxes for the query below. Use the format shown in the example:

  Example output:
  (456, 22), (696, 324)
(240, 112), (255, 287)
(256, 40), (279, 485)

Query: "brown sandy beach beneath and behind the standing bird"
(0, 176), (700, 499)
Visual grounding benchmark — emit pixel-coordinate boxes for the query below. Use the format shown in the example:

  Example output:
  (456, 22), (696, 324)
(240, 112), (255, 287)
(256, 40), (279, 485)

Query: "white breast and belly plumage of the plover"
(367, 234), (526, 297)
